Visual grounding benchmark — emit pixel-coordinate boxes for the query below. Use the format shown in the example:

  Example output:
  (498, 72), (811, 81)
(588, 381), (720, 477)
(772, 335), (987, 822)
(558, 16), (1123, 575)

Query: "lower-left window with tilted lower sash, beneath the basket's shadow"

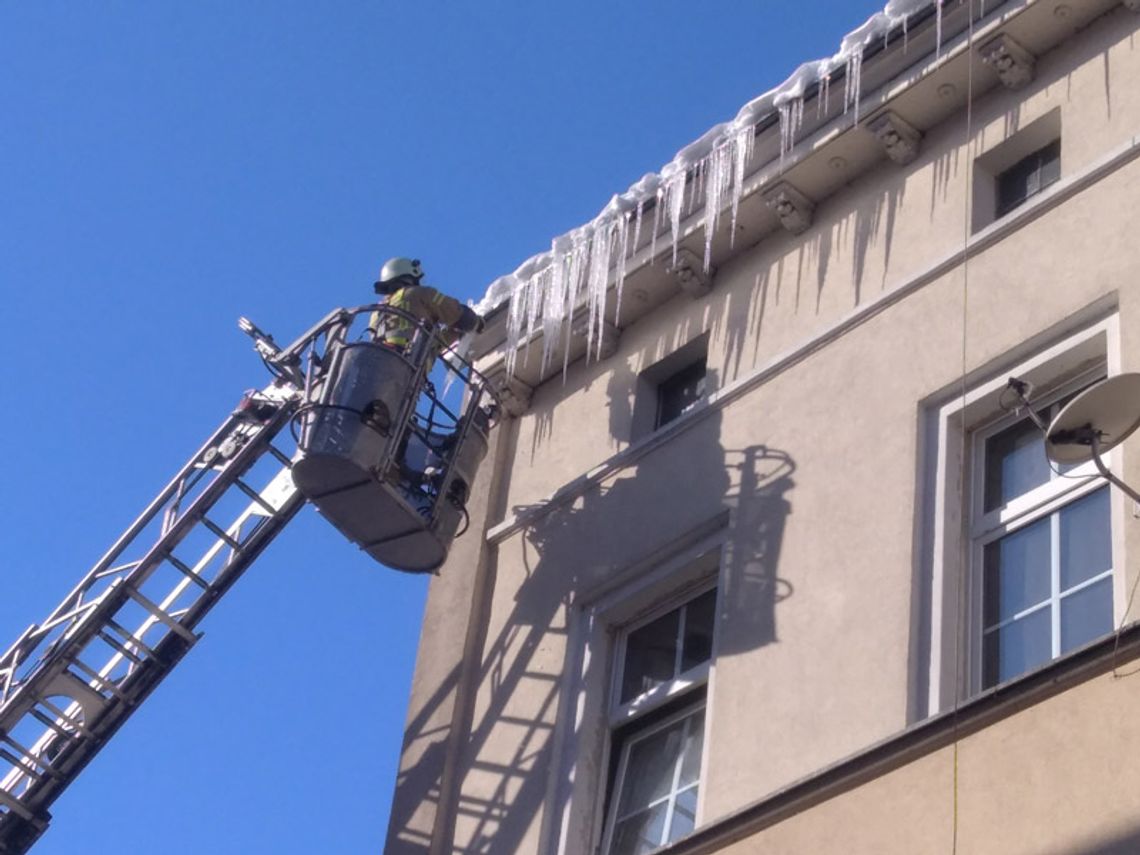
(604, 588), (716, 855)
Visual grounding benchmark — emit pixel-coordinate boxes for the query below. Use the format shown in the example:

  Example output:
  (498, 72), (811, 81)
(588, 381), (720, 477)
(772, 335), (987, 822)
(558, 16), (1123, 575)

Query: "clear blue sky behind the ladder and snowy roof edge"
(0, 0), (881, 854)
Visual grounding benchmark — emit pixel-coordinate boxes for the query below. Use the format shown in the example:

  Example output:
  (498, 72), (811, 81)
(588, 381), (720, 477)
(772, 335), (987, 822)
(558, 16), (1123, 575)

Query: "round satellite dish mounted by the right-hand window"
(1045, 373), (1140, 469)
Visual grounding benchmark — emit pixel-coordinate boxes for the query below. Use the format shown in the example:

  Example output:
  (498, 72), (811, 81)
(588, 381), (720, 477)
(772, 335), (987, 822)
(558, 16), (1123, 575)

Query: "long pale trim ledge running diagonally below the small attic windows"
(487, 135), (1140, 544)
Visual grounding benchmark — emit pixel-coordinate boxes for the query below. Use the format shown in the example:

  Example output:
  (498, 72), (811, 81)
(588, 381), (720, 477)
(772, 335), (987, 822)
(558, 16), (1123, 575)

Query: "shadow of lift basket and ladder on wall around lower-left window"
(444, 412), (795, 854)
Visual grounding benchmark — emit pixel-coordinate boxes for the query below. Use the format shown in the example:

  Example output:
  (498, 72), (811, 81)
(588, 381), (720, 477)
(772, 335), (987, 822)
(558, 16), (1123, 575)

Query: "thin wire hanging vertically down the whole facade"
(950, 0), (974, 855)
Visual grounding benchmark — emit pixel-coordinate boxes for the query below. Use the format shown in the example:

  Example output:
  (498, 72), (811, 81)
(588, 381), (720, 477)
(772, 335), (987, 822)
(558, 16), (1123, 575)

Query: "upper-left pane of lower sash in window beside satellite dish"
(983, 516), (1051, 628)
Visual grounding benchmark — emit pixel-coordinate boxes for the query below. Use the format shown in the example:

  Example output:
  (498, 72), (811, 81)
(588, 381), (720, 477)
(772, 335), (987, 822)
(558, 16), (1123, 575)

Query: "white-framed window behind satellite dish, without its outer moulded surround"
(972, 373), (1113, 689)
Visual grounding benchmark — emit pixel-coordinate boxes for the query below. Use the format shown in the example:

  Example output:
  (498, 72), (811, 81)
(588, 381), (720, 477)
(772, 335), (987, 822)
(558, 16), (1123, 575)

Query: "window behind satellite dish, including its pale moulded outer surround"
(911, 314), (1125, 720)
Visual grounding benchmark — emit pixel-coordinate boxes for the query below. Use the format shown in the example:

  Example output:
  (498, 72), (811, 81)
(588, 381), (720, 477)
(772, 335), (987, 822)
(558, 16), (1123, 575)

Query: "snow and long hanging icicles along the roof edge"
(474, 0), (945, 374)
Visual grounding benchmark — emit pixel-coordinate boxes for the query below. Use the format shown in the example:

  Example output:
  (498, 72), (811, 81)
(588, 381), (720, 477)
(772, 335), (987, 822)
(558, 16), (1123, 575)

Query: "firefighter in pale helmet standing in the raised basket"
(368, 258), (483, 350)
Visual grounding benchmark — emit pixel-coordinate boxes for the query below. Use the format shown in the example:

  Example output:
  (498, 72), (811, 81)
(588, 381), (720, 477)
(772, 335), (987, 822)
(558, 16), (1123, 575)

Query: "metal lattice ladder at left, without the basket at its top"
(0, 383), (303, 853)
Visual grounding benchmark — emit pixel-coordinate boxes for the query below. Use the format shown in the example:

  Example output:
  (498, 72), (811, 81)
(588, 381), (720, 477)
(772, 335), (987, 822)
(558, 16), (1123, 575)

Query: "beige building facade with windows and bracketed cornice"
(386, 0), (1140, 855)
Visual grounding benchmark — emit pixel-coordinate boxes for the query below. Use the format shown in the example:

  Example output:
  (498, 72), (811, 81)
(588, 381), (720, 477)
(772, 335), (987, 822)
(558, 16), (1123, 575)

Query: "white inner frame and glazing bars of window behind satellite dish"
(967, 365), (1119, 695)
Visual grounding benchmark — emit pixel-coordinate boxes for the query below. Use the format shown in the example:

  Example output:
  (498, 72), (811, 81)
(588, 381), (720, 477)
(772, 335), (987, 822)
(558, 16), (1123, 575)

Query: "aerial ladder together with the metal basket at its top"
(0, 307), (486, 855)
